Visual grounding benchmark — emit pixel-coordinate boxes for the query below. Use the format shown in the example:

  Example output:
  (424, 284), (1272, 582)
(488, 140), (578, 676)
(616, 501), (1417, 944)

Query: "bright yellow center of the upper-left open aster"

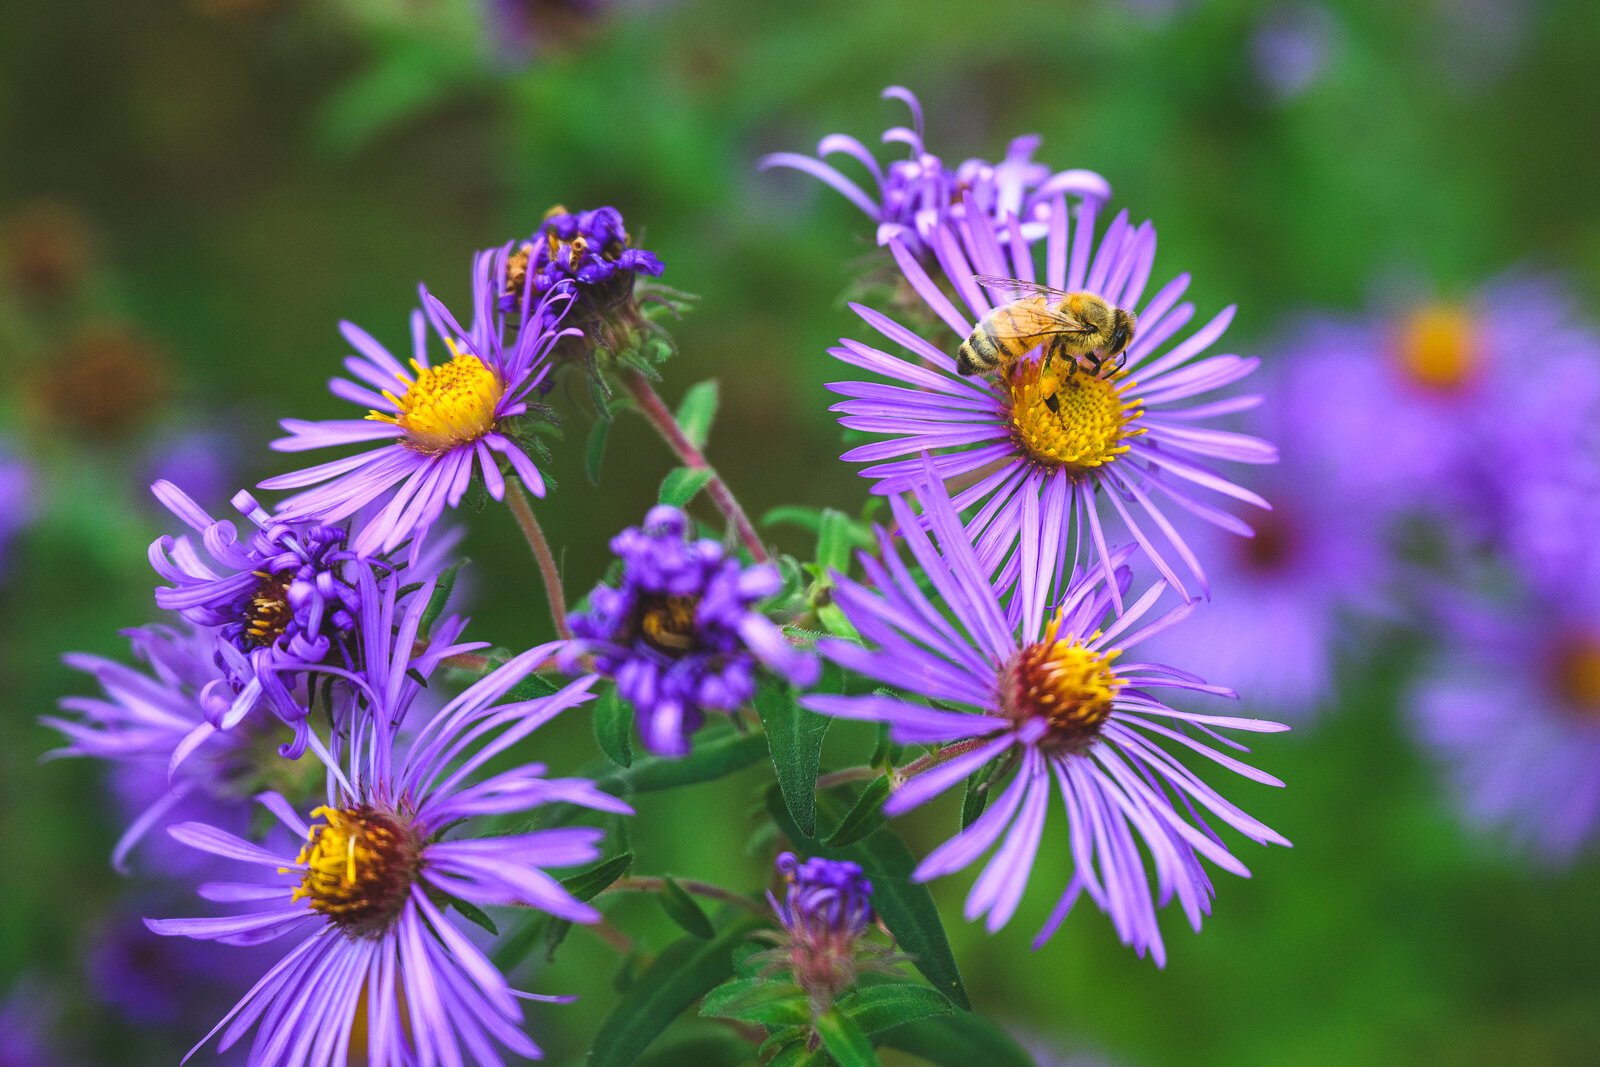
(366, 341), (506, 456)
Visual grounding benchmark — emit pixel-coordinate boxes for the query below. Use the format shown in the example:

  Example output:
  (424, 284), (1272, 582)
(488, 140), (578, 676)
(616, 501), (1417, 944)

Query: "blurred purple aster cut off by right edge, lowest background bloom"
(1410, 582), (1600, 864)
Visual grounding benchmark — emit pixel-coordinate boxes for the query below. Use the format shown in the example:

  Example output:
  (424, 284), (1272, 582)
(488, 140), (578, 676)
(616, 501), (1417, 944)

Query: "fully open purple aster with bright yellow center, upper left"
(252, 253), (571, 555)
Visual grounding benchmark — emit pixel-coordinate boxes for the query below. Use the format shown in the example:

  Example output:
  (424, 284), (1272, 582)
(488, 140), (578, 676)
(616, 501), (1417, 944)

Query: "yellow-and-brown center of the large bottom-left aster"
(294, 806), (422, 937)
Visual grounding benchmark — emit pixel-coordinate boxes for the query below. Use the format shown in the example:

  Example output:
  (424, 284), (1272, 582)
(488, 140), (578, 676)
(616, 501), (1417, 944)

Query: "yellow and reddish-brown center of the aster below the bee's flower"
(1000, 616), (1126, 752)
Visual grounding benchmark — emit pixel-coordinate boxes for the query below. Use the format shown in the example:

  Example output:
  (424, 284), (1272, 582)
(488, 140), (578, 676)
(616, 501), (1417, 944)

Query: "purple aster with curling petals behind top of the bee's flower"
(760, 85), (1110, 256)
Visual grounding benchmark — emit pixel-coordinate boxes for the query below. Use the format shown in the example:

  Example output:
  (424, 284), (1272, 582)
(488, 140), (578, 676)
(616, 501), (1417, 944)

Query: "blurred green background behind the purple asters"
(0, 0), (1600, 1064)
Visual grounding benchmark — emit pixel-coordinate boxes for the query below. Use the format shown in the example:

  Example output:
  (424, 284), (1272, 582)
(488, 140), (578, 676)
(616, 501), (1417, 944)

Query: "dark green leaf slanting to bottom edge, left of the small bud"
(589, 915), (760, 1067)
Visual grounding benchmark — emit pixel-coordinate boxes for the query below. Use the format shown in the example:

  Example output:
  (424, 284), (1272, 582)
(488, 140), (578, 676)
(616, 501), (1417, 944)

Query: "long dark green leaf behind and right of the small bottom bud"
(766, 787), (966, 1011)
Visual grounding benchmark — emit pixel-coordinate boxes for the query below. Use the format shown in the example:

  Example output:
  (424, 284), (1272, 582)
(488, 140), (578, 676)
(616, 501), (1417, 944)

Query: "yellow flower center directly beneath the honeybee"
(1010, 360), (1144, 470)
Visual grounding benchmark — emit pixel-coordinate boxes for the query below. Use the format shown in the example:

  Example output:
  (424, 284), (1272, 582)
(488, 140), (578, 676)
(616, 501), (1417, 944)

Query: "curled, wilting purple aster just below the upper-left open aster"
(150, 482), (362, 758)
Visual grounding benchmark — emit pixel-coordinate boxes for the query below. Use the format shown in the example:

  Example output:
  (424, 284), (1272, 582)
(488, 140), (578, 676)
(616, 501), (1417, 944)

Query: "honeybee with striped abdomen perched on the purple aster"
(955, 275), (1136, 376)
